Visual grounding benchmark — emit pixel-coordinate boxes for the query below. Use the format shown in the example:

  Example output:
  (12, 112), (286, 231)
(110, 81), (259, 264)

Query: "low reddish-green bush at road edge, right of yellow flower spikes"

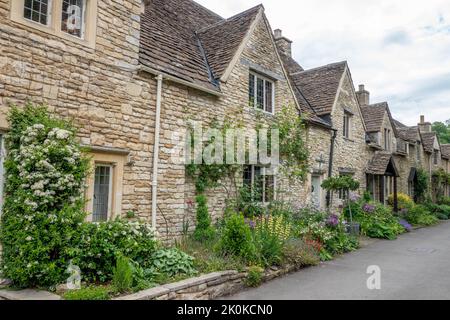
(283, 238), (320, 267)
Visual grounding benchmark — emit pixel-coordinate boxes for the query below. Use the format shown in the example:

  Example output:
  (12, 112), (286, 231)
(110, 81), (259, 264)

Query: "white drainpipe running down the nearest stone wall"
(152, 74), (163, 230)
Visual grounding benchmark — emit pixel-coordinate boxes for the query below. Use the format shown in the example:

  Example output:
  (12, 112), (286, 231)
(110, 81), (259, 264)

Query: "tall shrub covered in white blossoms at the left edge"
(0, 104), (88, 287)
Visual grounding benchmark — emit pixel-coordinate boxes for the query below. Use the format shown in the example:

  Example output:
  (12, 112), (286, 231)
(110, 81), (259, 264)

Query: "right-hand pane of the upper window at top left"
(61, 0), (85, 38)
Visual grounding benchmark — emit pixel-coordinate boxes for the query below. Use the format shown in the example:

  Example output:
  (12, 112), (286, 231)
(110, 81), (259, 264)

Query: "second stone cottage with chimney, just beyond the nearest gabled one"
(275, 30), (366, 207)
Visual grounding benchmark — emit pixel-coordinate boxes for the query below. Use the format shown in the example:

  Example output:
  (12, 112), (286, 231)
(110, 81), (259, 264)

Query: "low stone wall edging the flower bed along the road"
(113, 265), (299, 300)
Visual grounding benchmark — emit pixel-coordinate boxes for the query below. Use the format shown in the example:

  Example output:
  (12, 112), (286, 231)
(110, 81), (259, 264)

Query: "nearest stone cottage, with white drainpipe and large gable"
(0, 0), (330, 238)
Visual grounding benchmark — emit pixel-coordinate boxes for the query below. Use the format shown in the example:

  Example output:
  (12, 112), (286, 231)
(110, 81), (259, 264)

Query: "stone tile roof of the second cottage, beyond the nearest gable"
(289, 61), (347, 116)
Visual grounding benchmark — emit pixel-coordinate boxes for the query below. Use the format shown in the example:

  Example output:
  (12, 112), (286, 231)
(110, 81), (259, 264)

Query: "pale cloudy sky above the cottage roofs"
(196, 0), (450, 125)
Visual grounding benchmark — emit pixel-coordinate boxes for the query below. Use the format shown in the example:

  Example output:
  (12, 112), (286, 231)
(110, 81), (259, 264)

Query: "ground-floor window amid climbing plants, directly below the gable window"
(243, 165), (276, 203)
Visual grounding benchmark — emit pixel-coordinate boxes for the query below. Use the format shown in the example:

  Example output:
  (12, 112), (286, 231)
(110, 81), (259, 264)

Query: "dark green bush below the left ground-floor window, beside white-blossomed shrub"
(69, 219), (157, 282)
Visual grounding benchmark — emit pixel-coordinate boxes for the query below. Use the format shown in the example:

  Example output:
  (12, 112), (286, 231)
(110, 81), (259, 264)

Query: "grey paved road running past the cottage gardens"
(227, 221), (450, 300)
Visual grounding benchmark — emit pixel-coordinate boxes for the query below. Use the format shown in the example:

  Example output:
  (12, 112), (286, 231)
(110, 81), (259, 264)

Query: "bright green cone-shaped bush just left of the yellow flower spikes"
(218, 213), (256, 261)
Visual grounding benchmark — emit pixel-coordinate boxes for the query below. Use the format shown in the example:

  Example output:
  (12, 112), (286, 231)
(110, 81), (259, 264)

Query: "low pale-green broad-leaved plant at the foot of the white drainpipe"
(149, 248), (197, 277)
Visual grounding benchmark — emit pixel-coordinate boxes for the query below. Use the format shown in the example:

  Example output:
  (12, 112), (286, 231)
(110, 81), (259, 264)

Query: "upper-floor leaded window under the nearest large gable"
(248, 72), (275, 114)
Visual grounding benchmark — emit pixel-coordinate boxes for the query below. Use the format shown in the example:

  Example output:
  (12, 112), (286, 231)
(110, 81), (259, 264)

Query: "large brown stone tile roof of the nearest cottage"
(140, 0), (262, 91)
